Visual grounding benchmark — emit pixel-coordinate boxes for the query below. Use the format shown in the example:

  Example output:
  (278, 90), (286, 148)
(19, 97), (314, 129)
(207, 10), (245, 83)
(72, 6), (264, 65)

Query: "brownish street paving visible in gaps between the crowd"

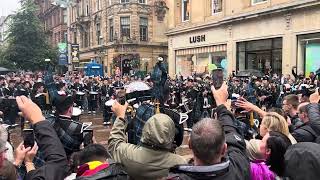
(10, 113), (191, 158)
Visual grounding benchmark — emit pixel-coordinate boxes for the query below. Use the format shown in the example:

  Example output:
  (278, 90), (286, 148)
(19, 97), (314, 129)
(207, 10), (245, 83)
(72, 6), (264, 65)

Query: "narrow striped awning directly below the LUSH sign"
(176, 44), (227, 56)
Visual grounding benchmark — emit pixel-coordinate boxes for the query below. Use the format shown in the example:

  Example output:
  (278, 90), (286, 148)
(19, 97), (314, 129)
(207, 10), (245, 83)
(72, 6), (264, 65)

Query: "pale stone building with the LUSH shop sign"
(166, 0), (320, 76)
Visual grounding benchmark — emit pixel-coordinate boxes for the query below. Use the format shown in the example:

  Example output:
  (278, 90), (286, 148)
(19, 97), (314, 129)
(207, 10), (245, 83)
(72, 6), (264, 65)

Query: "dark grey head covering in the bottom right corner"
(284, 142), (320, 180)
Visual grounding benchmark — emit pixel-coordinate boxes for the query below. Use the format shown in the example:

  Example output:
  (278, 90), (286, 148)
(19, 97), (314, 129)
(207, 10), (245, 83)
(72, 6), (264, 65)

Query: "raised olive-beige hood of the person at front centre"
(141, 114), (175, 150)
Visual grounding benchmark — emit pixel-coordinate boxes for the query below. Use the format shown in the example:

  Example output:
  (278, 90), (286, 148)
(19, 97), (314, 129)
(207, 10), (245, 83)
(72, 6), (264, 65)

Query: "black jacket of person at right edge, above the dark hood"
(292, 104), (320, 142)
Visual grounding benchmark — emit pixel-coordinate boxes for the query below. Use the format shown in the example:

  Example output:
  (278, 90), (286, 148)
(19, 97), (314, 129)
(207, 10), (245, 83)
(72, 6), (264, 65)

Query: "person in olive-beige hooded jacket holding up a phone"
(108, 102), (186, 179)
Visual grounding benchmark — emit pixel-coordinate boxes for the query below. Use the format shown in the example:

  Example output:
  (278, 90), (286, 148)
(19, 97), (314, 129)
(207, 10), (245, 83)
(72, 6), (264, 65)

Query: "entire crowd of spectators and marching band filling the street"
(0, 62), (320, 180)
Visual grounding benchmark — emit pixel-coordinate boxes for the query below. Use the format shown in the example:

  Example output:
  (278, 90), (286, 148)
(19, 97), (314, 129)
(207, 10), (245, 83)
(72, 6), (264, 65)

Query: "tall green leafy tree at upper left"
(0, 0), (57, 70)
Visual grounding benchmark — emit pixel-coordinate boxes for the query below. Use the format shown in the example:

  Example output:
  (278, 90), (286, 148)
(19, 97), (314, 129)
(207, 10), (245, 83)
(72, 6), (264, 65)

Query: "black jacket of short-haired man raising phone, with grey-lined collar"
(168, 105), (250, 180)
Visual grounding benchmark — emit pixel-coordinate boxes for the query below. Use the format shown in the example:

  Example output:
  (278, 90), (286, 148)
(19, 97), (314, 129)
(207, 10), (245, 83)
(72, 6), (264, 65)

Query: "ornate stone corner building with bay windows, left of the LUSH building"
(69, 0), (168, 75)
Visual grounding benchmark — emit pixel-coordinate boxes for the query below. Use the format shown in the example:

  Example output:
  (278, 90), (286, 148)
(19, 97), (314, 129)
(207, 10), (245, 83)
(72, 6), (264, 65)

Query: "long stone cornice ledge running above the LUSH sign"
(165, 0), (320, 36)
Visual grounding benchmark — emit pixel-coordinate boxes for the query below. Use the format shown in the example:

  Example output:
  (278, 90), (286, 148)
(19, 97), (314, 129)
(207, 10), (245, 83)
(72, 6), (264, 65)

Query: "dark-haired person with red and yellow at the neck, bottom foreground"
(77, 144), (129, 180)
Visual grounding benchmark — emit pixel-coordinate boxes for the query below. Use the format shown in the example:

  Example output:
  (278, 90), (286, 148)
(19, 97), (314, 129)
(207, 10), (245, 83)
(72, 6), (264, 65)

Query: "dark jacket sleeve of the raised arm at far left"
(24, 121), (68, 180)
